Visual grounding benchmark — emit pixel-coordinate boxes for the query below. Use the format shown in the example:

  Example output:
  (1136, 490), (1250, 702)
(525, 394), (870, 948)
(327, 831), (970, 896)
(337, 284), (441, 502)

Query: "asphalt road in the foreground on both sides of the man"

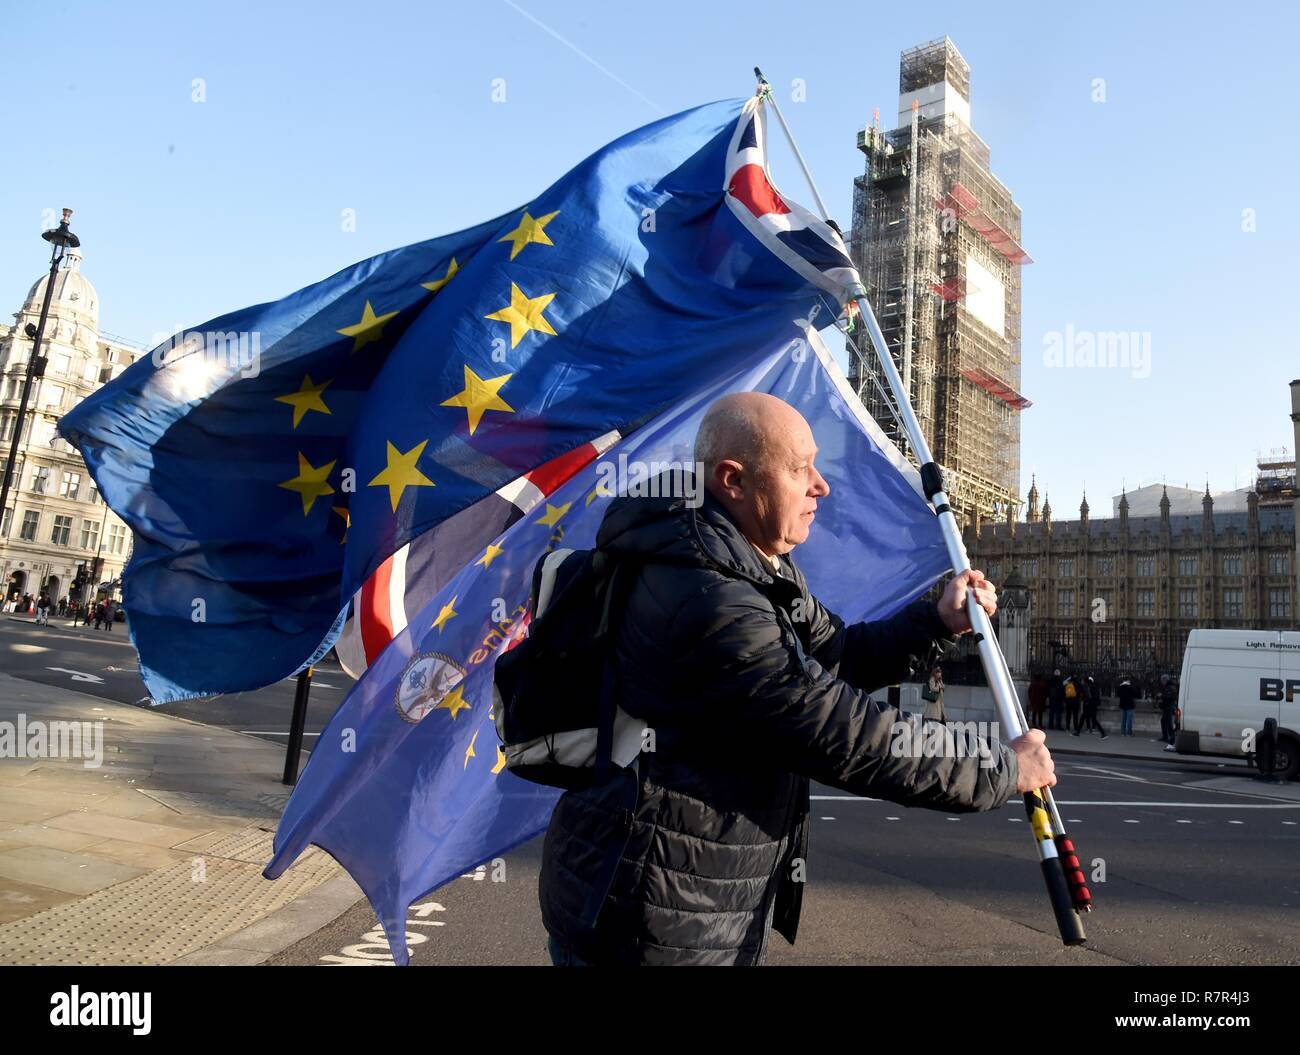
(263, 756), (1300, 965)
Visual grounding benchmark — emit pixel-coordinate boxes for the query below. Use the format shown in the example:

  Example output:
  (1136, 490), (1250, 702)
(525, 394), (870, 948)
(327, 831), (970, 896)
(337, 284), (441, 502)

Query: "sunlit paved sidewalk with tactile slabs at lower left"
(0, 674), (363, 964)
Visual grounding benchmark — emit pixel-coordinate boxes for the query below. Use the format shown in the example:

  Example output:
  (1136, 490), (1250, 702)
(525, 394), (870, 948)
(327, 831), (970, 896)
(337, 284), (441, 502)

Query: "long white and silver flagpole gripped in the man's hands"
(754, 76), (1092, 945)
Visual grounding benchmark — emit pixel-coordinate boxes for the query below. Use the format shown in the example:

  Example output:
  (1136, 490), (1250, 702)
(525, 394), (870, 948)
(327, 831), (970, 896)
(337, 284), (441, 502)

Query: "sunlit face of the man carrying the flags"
(746, 417), (831, 553)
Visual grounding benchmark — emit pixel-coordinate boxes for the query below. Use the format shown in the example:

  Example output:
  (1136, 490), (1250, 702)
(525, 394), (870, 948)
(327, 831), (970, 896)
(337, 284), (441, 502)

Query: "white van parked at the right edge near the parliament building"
(1174, 630), (1300, 780)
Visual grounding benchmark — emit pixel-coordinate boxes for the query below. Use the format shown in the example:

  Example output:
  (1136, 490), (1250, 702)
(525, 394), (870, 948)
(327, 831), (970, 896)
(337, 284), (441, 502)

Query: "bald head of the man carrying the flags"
(696, 392), (831, 556)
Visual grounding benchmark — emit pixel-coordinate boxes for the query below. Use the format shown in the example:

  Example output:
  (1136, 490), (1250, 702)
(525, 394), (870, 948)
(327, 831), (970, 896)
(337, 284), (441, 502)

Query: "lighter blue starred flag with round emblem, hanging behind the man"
(265, 330), (949, 964)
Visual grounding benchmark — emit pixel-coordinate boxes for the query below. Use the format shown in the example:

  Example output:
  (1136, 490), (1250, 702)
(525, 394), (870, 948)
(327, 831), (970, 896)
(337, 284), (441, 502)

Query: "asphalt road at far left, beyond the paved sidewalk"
(0, 615), (352, 750)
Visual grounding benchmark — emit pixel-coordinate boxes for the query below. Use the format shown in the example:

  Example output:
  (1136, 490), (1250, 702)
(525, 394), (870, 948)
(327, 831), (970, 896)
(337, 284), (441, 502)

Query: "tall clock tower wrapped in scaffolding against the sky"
(850, 36), (1032, 518)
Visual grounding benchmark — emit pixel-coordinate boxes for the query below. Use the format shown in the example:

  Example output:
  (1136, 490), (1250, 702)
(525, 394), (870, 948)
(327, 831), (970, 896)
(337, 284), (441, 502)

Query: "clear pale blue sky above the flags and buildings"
(0, 0), (1300, 518)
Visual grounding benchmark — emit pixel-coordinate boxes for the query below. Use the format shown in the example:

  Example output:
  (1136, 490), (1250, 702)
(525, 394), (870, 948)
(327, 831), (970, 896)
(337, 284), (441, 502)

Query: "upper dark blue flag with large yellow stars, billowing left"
(60, 99), (852, 702)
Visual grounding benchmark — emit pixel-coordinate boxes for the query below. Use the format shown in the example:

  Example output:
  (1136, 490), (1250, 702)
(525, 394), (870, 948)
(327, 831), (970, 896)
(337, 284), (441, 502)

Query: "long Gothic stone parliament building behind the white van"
(965, 381), (1300, 674)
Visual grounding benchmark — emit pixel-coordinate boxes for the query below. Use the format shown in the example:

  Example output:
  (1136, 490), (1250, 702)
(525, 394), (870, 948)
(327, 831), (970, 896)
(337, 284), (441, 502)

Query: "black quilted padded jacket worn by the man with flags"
(540, 494), (1018, 965)
